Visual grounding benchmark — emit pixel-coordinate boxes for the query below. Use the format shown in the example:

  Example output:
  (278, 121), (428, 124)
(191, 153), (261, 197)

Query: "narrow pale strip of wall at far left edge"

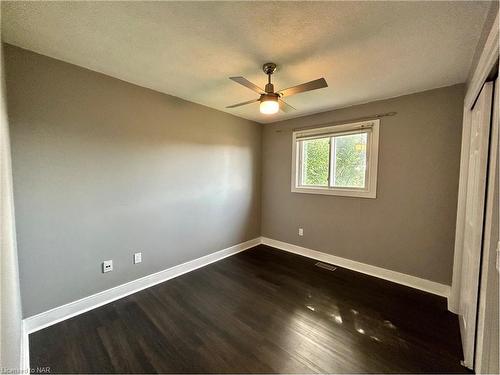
(0, 46), (22, 373)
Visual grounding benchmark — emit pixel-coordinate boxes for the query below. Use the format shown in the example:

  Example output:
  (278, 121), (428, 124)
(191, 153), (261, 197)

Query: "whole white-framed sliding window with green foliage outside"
(292, 120), (379, 198)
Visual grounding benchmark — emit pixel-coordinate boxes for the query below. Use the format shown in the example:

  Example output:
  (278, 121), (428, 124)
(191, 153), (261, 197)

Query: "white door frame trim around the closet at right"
(448, 13), (499, 369)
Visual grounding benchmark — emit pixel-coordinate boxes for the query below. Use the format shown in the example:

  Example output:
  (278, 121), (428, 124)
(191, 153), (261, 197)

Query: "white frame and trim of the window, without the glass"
(292, 120), (380, 198)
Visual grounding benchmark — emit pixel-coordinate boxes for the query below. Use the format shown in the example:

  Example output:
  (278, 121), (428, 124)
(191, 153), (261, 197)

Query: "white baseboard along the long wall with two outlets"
(23, 237), (261, 334)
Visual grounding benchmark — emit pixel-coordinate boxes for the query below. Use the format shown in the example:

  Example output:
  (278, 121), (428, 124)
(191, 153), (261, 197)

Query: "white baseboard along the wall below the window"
(262, 237), (450, 298)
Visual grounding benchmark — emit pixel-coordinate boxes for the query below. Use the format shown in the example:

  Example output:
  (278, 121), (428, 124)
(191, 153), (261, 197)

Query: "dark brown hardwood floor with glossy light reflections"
(30, 245), (466, 373)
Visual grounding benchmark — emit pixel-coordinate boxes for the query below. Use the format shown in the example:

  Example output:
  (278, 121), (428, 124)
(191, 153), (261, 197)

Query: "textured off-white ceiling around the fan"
(2, 1), (490, 123)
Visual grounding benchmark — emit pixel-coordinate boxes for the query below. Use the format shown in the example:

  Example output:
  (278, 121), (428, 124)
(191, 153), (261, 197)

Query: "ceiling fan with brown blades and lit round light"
(226, 63), (328, 115)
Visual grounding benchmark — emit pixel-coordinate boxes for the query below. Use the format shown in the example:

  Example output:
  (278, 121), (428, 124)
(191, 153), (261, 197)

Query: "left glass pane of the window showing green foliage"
(302, 138), (330, 186)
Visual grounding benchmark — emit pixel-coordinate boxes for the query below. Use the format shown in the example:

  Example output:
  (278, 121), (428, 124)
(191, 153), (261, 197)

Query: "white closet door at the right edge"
(460, 82), (493, 368)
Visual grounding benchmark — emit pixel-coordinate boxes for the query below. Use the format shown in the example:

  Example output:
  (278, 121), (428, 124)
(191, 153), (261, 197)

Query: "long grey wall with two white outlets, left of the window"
(5, 46), (262, 317)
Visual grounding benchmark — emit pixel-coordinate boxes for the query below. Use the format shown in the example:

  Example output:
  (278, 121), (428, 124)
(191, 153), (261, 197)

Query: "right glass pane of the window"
(332, 133), (368, 188)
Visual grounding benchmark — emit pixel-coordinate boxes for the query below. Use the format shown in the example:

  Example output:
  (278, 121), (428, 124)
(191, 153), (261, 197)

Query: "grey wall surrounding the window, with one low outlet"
(262, 85), (464, 284)
